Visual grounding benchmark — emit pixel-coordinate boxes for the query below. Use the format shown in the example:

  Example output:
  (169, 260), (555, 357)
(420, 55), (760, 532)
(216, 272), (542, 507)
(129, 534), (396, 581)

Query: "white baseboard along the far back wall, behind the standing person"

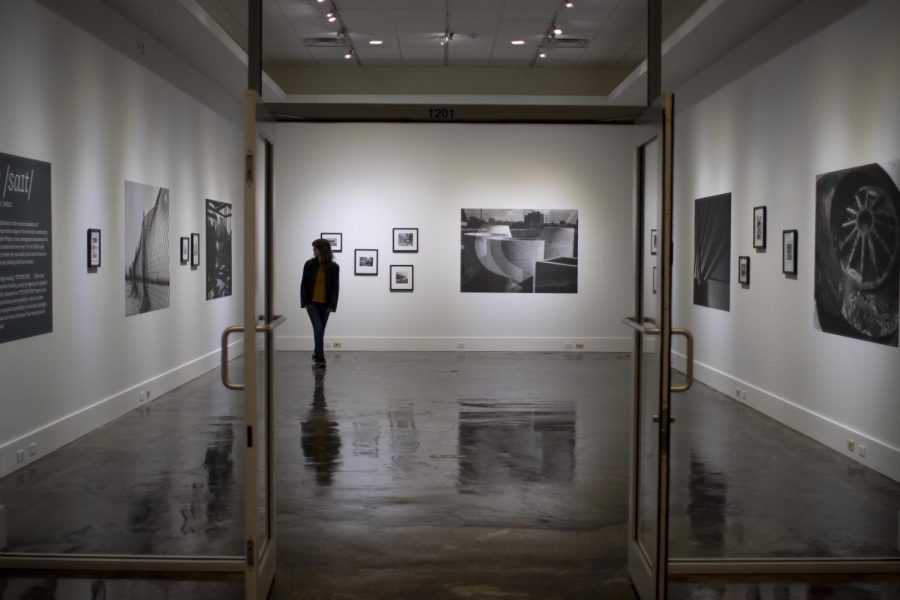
(275, 335), (631, 352)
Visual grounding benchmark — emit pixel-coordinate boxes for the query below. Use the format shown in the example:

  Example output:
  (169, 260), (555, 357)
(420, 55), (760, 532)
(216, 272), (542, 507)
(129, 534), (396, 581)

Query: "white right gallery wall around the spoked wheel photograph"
(674, 0), (900, 480)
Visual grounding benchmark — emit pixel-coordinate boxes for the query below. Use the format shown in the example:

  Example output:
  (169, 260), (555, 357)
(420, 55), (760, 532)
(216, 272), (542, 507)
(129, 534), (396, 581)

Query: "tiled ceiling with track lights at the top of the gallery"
(198, 0), (704, 69)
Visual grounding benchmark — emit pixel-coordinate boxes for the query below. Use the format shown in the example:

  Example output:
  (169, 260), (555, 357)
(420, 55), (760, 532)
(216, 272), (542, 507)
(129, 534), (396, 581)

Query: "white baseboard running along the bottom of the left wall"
(0, 340), (244, 477)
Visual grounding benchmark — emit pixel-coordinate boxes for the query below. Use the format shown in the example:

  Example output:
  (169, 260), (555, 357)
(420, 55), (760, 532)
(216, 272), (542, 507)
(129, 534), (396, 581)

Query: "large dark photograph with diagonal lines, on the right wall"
(694, 193), (731, 310)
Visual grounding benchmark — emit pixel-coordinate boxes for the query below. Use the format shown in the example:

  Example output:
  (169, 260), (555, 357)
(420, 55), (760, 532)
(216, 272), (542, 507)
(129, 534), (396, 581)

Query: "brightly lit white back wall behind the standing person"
(275, 123), (634, 351)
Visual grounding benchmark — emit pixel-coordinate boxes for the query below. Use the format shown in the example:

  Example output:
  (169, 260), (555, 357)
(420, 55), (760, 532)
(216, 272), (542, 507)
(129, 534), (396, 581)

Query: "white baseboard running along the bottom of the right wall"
(672, 352), (900, 482)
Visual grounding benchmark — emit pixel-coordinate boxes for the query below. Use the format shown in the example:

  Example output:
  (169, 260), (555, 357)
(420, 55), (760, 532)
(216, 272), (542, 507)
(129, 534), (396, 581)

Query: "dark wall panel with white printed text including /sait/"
(0, 153), (53, 343)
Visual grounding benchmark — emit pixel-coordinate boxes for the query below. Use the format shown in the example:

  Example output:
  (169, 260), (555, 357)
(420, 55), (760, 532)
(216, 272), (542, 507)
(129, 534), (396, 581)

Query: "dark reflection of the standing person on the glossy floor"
(300, 368), (341, 485)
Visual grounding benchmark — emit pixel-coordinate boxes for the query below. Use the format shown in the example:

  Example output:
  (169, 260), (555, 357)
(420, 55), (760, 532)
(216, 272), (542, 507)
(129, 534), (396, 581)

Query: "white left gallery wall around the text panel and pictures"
(0, 0), (243, 476)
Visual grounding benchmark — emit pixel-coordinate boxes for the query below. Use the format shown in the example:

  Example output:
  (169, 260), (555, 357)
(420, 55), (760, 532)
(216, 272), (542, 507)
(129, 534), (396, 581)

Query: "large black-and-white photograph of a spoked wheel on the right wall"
(813, 161), (900, 347)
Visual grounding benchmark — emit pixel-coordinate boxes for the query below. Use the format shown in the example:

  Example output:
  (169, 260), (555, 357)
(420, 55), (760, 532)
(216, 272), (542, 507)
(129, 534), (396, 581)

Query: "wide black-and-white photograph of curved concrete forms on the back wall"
(459, 208), (578, 294)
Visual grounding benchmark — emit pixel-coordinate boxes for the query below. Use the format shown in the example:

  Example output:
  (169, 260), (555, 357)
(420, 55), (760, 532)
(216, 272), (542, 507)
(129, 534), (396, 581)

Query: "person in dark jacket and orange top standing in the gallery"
(300, 239), (340, 368)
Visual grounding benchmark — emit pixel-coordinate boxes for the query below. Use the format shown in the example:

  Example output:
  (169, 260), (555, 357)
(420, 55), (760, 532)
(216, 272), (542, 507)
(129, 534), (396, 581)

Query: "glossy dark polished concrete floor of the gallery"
(0, 352), (900, 600)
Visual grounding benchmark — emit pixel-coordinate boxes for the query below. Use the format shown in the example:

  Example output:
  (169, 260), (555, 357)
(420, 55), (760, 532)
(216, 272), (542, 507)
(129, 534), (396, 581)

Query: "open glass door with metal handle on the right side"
(624, 95), (692, 600)
